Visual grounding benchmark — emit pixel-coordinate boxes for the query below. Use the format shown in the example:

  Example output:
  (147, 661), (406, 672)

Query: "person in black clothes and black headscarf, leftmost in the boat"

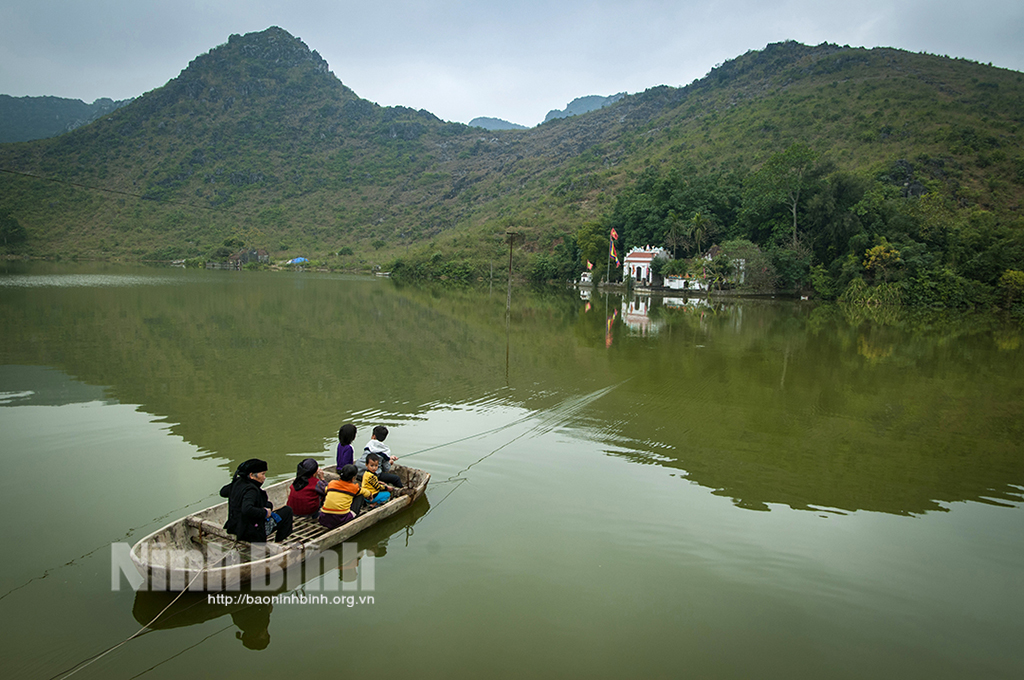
(220, 458), (292, 543)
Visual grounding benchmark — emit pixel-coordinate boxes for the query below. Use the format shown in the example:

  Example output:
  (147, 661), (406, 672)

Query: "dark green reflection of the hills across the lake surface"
(0, 262), (1024, 514)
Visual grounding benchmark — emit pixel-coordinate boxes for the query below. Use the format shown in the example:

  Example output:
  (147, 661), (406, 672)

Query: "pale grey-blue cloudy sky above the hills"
(0, 0), (1024, 126)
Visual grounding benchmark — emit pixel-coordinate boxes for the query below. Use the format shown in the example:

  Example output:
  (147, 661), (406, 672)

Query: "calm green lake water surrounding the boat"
(0, 265), (1024, 678)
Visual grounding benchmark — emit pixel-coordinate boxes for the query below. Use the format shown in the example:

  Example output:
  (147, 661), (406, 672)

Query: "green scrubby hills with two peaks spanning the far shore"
(0, 28), (1024, 307)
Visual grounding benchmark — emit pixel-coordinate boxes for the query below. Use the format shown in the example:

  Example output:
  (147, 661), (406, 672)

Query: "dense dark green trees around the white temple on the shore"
(577, 144), (1024, 306)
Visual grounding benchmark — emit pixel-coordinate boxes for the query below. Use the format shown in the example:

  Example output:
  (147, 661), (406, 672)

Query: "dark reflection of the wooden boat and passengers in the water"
(131, 496), (430, 649)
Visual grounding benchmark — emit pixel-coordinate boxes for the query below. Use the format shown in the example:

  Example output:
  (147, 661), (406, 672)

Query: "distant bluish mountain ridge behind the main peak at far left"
(0, 94), (131, 143)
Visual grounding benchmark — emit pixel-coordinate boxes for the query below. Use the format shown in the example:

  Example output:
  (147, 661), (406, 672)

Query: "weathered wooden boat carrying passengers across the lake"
(130, 464), (430, 591)
